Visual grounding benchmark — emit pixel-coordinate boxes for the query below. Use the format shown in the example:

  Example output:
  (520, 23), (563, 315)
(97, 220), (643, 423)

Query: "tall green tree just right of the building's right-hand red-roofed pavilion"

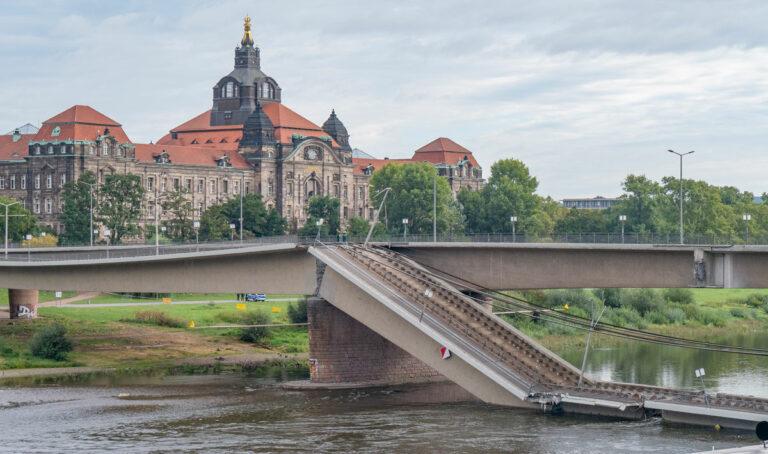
(458, 159), (557, 235)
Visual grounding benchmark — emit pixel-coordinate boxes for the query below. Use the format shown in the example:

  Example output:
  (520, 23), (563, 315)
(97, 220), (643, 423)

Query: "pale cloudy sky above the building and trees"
(0, 0), (768, 198)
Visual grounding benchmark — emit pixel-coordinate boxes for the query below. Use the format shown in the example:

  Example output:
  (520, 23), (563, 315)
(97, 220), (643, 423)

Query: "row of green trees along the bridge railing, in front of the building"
(0, 159), (768, 244)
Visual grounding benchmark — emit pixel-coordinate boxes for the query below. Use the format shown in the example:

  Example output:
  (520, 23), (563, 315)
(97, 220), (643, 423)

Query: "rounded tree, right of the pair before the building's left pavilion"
(99, 173), (144, 244)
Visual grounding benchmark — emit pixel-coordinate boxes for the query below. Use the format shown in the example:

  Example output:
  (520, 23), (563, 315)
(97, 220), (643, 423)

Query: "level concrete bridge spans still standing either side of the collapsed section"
(0, 236), (768, 294)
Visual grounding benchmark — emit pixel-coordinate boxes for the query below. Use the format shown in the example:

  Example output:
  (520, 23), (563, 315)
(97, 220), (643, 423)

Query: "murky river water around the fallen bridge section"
(0, 336), (768, 454)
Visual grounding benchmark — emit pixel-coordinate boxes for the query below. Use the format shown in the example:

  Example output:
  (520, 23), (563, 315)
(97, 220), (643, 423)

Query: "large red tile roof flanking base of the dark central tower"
(157, 102), (339, 150)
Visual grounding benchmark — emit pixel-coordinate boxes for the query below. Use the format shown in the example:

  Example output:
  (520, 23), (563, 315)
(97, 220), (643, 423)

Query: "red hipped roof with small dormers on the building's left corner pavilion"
(33, 105), (131, 143)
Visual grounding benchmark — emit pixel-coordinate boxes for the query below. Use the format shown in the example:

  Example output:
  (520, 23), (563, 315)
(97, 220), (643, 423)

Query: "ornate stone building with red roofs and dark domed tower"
(0, 17), (484, 238)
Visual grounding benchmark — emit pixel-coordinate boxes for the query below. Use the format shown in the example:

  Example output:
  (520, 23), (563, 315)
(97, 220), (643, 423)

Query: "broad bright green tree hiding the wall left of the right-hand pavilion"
(370, 163), (462, 234)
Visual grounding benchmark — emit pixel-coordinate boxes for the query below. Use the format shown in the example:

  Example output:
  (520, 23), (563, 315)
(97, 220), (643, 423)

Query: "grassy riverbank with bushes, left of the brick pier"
(0, 294), (308, 370)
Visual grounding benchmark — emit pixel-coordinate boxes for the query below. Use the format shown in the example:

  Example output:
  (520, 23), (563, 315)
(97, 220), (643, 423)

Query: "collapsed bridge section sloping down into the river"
(310, 246), (768, 430)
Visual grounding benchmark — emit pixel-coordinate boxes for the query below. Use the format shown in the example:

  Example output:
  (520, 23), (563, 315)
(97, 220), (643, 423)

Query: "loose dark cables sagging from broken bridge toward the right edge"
(354, 245), (768, 356)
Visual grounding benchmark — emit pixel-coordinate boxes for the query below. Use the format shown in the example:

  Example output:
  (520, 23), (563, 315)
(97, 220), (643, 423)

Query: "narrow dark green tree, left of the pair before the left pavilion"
(59, 171), (98, 245)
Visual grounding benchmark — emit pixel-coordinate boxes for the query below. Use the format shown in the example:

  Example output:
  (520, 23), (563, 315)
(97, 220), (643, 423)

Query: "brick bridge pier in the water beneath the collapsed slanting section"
(307, 298), (445, 386)
